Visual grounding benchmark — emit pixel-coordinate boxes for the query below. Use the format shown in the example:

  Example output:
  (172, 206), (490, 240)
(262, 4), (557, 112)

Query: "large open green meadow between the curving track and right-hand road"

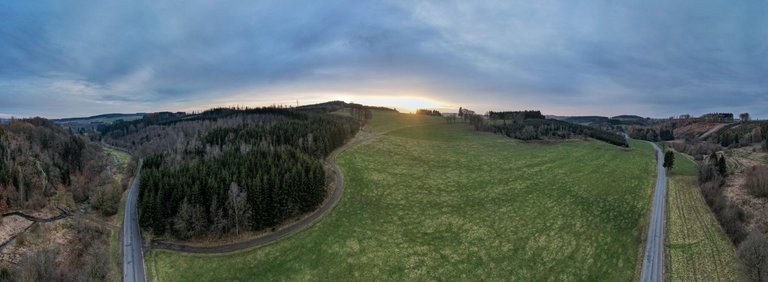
(146, 112), (656, 281)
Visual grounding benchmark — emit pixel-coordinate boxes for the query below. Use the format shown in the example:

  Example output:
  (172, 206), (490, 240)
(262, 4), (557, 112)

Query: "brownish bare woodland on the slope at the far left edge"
(0, 115), (108, 211)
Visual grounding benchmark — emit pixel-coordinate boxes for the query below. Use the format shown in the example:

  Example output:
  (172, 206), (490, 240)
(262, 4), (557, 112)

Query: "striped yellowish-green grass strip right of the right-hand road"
(666, 153), (741, 281)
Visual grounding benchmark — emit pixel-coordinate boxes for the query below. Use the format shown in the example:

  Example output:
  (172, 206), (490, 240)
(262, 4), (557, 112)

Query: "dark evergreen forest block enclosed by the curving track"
(123, 107), (366, 239)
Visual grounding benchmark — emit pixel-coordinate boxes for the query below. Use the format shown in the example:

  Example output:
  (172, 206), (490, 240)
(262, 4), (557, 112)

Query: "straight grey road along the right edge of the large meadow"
(640, 142), (667, 282)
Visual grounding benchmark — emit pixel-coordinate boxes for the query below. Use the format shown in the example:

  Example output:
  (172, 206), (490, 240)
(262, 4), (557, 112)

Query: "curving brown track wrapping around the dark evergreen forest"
(152, 142), (348, 254)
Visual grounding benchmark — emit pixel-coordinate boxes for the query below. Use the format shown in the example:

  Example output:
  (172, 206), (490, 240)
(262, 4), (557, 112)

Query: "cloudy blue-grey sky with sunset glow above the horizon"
(0, 0), (768, 118)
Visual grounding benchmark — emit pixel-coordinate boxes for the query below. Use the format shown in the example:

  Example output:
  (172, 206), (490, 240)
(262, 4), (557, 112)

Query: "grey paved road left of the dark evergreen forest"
(122, 160), (146, 282)
